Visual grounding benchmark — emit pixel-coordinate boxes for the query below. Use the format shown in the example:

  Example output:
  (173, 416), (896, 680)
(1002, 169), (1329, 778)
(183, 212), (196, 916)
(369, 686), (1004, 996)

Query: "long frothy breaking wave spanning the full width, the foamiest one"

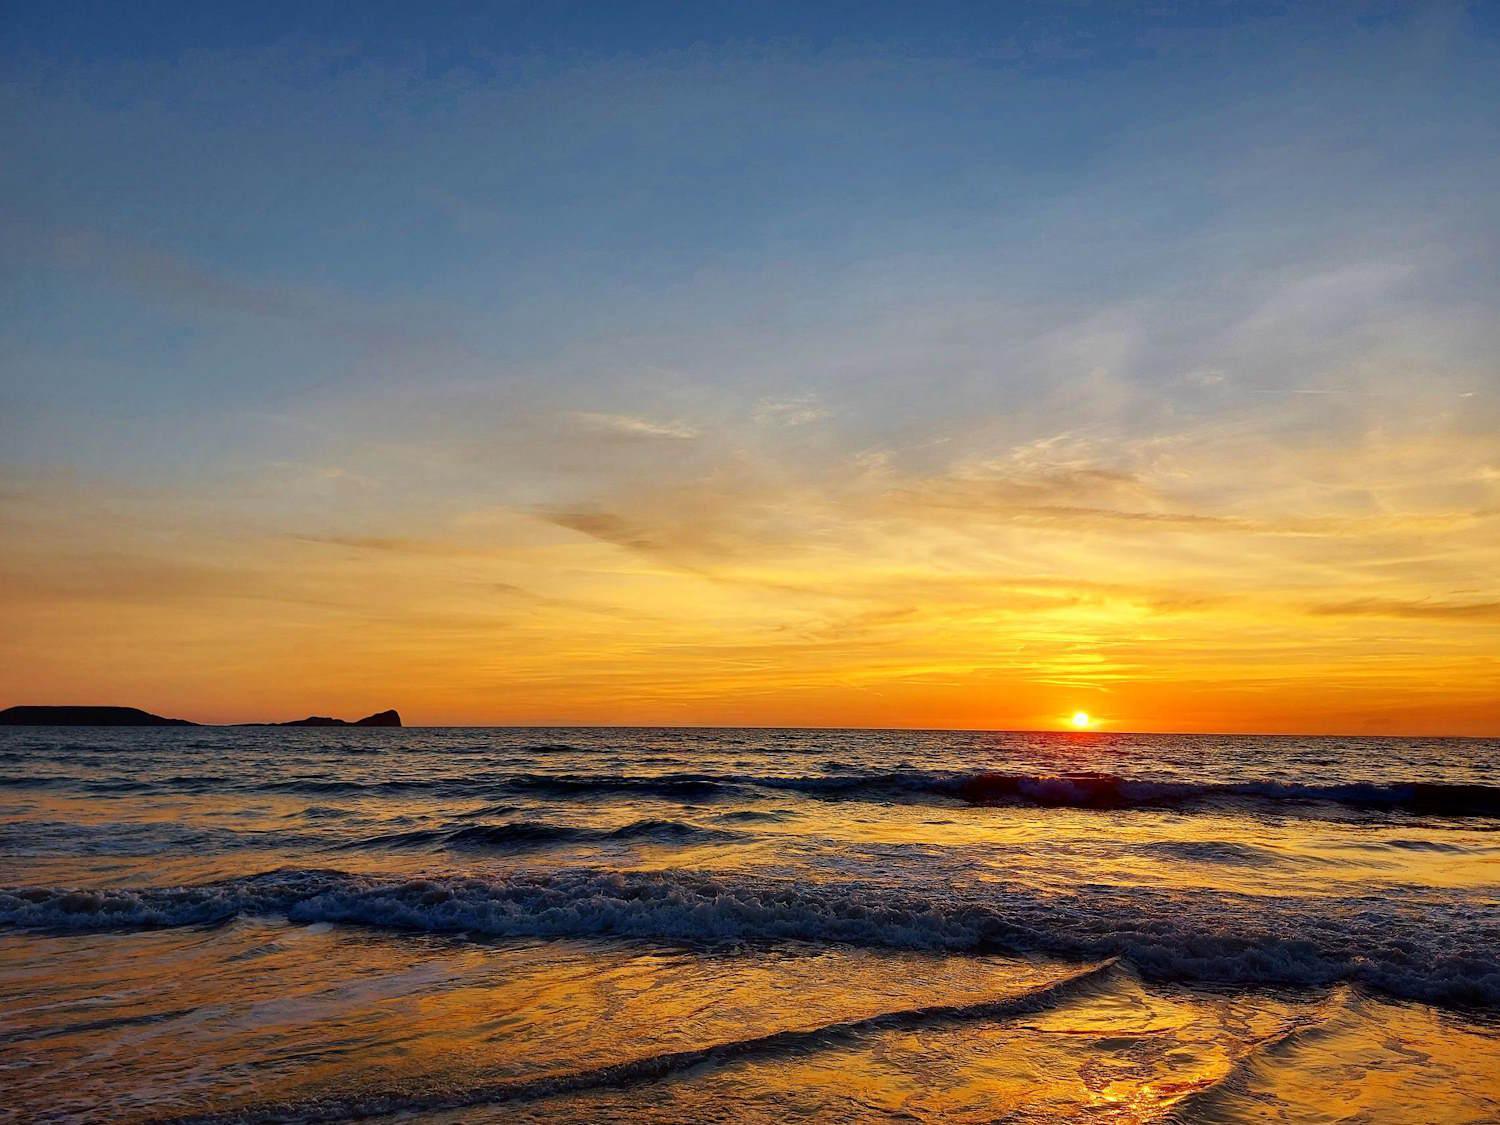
(0, 869), (1500, 1005)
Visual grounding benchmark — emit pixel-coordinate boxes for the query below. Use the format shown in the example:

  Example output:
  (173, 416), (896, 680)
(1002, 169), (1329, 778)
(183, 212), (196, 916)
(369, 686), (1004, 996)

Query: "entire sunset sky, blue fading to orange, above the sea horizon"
(0, 2), (1500, 735)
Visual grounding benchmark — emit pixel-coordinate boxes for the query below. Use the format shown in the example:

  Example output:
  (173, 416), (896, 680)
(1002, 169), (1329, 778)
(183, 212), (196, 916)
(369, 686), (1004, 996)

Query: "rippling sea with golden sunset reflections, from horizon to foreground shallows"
(0, 728), (1500, 1125)
